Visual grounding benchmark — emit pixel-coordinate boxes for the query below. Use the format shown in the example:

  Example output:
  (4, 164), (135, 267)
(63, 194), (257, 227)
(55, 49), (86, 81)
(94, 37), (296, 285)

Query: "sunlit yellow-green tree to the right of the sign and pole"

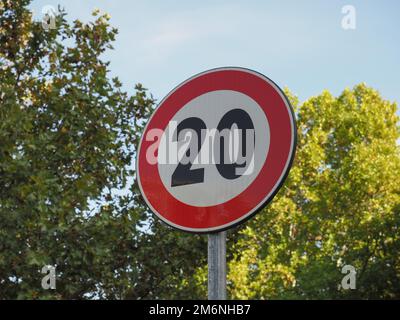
(229, 84), (400, 299)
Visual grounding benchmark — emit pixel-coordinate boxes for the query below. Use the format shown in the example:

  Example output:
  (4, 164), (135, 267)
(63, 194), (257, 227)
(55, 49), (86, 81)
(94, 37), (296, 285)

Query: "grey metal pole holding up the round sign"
(208, 231), (226, 300)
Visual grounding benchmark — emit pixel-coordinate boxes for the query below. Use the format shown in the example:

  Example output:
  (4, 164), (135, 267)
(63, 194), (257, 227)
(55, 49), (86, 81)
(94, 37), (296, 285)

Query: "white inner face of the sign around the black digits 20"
(158, 90), (269, 207)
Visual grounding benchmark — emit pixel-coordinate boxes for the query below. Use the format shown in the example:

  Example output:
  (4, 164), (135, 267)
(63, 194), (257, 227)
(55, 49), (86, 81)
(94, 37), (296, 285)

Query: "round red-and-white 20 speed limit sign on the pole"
(136, 67), (296, 233)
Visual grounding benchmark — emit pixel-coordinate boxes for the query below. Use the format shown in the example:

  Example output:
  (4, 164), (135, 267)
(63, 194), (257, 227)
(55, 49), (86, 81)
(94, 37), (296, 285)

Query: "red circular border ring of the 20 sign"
(137, 69), (295, 232)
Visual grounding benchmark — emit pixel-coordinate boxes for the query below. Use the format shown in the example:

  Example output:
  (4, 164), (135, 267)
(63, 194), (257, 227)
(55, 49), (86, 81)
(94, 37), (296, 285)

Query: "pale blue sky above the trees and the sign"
(31, 0), (400, 109)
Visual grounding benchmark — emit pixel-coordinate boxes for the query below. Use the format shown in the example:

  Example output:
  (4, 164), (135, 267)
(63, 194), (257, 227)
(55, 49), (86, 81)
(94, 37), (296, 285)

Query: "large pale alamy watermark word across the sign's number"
(144, 121), (255, 175)
